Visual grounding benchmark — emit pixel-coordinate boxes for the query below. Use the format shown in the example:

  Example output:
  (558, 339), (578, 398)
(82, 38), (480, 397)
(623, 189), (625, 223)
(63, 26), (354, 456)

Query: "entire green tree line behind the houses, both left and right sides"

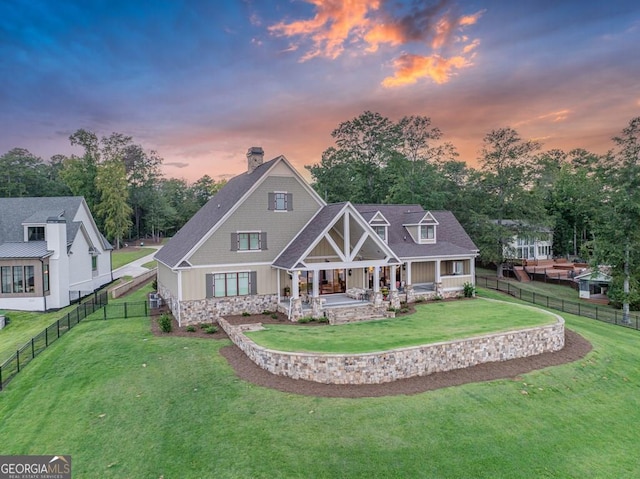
(0, 116), (640, 312)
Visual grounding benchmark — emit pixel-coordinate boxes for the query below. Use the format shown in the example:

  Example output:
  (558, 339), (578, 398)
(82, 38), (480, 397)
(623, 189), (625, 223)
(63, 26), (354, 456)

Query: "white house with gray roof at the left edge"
(0, 196), (113, 311)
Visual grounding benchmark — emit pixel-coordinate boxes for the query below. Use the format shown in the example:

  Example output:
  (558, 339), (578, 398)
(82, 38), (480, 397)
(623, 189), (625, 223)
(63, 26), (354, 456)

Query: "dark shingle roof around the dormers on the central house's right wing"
(355, 205), (478, 258)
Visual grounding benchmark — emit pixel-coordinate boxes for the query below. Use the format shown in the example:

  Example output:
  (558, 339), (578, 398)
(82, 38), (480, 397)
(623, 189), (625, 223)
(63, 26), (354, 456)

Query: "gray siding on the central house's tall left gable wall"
(188, 176), (320, 266)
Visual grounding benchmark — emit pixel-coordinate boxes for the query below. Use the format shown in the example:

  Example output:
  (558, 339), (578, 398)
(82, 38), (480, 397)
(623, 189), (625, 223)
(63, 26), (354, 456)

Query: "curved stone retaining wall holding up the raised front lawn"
(218, 300), (564, 384)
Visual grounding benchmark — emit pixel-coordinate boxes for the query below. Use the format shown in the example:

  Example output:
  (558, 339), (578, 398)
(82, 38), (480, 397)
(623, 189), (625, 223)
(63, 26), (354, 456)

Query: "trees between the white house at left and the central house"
(0, 129), (224, 248)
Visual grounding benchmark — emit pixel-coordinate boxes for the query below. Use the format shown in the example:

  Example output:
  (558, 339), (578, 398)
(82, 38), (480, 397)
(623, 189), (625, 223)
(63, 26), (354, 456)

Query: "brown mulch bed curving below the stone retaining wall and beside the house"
(151, 308), (591, 398)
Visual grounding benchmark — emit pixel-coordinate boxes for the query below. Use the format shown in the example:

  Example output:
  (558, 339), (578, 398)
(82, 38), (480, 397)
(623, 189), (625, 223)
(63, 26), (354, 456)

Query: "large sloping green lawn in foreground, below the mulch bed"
(0, 290), (640, 479)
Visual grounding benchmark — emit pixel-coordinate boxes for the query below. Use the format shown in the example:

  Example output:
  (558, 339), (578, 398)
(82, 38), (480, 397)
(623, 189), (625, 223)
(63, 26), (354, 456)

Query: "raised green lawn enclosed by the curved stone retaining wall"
(246, 299), (556, 353)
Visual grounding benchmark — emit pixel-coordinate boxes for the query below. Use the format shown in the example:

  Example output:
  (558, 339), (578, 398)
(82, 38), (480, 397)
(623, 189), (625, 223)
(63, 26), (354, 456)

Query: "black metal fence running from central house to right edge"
(476, 276), (640, 329)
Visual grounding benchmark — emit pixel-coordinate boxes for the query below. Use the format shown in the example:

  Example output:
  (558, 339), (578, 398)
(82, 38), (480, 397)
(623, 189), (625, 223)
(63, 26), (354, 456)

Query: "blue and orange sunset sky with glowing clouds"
(0, 0), (640, 182)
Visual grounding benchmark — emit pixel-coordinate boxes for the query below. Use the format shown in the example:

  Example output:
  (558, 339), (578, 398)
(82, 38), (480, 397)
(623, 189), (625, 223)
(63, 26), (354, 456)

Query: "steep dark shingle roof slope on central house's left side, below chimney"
(155, 157), (282, 268)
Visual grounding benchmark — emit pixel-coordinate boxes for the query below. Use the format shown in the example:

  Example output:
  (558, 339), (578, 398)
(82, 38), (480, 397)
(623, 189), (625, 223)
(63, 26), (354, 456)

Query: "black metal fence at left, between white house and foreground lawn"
(0, 292), (150, 391)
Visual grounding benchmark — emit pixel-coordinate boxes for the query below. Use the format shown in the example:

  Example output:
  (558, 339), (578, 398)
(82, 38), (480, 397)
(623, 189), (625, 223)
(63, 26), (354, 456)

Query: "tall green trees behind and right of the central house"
(307, 111), (640, 317)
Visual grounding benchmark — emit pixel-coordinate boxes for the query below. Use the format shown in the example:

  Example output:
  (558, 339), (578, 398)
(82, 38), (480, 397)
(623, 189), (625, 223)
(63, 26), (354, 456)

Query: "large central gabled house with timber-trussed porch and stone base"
(156, 147), (478, 324)
